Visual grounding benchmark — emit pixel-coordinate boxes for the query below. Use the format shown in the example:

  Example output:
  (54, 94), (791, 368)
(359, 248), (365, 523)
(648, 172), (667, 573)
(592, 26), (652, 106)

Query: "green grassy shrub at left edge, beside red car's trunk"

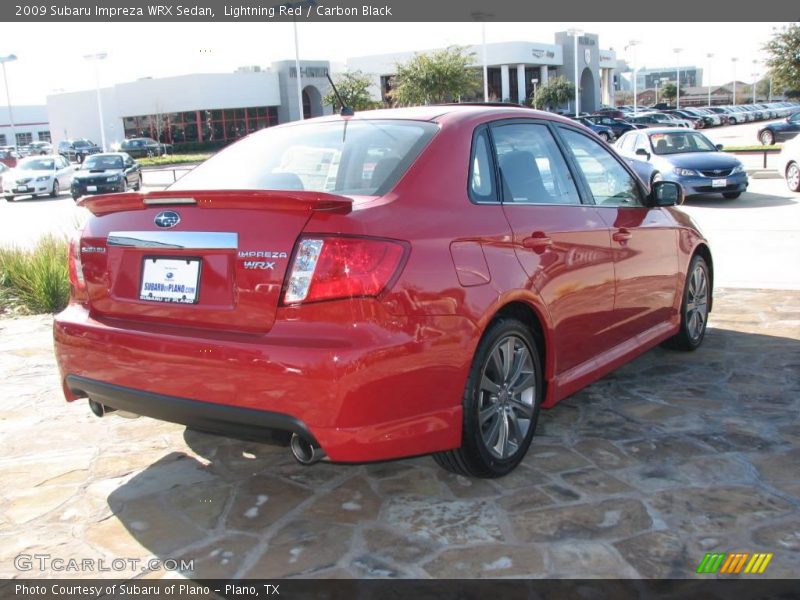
(0, 235), (69, 313)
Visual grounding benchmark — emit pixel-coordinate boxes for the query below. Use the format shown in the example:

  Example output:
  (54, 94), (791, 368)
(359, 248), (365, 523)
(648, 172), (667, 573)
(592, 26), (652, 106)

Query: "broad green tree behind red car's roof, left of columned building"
(389, 46), (482, 106)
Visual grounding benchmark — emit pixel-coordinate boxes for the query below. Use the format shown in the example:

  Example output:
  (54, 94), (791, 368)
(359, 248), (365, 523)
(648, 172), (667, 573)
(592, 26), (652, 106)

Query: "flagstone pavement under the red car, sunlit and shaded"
(0, 290), (800, 578)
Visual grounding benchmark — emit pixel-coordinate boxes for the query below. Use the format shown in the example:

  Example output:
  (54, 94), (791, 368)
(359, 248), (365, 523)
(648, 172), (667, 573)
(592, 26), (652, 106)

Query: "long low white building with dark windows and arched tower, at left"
(46, 61), (331, 148)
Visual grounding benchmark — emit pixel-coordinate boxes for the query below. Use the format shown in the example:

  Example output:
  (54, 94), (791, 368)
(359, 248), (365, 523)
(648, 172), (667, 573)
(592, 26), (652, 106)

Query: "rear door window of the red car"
(492, 123), (580, 204)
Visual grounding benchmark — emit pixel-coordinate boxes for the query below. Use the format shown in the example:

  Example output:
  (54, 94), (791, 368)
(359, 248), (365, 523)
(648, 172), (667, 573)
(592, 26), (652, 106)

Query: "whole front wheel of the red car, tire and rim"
(664, 254), (712, 351)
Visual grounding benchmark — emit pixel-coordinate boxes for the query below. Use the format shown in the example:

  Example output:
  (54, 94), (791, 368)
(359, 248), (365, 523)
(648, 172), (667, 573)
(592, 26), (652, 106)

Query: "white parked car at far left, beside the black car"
(3, 156), (75, 202)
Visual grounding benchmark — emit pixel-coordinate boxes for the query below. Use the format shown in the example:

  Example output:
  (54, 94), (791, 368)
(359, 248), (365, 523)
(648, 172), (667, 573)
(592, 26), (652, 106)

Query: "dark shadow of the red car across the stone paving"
(107, 326), (800, 579)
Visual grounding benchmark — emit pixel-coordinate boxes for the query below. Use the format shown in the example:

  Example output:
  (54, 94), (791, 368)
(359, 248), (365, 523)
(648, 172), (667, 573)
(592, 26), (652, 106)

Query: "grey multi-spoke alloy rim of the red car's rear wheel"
(478, 335), (536, 460)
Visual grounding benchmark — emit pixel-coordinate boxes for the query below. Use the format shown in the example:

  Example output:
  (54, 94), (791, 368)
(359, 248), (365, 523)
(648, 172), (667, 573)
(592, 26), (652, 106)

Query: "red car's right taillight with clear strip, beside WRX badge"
(283, 237), (406, 304)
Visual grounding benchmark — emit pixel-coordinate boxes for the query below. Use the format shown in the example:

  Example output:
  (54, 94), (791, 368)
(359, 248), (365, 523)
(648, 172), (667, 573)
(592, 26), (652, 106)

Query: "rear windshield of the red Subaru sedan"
(170, 120), (438, 196)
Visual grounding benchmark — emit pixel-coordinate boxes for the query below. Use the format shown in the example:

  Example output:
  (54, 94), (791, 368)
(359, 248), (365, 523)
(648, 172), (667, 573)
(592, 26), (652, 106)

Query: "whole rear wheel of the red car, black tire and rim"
(433, 318), (542, 478)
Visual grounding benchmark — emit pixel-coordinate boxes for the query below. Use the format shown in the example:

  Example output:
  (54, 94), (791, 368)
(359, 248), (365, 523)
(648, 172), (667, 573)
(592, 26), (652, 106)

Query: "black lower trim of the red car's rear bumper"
(67, 375), (319, 446)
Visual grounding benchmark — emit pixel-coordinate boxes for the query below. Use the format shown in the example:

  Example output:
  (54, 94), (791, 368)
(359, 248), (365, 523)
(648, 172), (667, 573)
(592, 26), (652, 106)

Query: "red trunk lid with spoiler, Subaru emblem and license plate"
(80, 190), (352, 333)
